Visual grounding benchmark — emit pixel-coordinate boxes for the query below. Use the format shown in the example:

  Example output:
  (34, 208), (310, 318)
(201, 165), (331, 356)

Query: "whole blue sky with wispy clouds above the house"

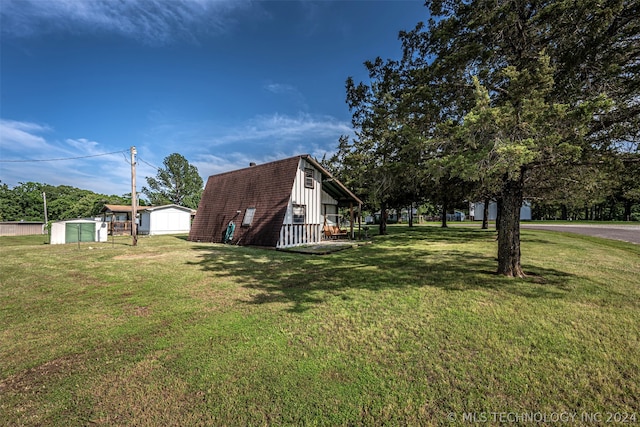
(0, 0), (427, 195)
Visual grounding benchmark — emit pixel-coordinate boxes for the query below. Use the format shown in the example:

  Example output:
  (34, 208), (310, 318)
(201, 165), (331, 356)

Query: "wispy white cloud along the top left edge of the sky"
(0, 0), (250, 43)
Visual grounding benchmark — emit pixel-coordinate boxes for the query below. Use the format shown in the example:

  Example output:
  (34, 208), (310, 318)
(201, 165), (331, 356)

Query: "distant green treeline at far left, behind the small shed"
(0, 182), (131, 221)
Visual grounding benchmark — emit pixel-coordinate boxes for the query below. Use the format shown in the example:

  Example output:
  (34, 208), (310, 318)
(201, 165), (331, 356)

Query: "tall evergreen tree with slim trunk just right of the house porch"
(332, 58), (426, 234)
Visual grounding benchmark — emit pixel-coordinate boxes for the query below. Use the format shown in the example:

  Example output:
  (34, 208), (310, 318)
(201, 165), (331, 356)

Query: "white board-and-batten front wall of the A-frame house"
(277, 159), (337, 248)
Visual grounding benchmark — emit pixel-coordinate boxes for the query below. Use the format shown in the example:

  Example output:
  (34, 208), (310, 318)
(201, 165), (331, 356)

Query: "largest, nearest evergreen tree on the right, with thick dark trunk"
(401, 0), (640, 276)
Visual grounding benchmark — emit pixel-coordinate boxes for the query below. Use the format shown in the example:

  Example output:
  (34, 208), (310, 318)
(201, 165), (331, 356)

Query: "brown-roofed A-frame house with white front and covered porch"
(189, 155), (362, 248)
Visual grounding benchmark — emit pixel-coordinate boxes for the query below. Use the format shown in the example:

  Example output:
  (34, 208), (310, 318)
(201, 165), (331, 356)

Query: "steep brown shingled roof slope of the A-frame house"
(189, 156), (300, 247)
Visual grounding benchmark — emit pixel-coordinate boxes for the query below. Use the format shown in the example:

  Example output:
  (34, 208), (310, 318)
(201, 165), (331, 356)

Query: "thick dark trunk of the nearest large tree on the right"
(498, 173), (525, 277)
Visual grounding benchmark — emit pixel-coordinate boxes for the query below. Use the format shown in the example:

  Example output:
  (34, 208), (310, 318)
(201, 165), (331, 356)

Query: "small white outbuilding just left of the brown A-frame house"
(138, 205), (195, 235)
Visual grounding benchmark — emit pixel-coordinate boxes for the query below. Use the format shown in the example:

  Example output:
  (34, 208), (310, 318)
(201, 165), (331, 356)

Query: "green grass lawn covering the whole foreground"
(0, 226), (640, 426)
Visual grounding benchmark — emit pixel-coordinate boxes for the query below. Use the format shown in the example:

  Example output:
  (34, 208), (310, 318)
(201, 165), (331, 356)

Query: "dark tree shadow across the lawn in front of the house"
(185, 227), (571, 312)
